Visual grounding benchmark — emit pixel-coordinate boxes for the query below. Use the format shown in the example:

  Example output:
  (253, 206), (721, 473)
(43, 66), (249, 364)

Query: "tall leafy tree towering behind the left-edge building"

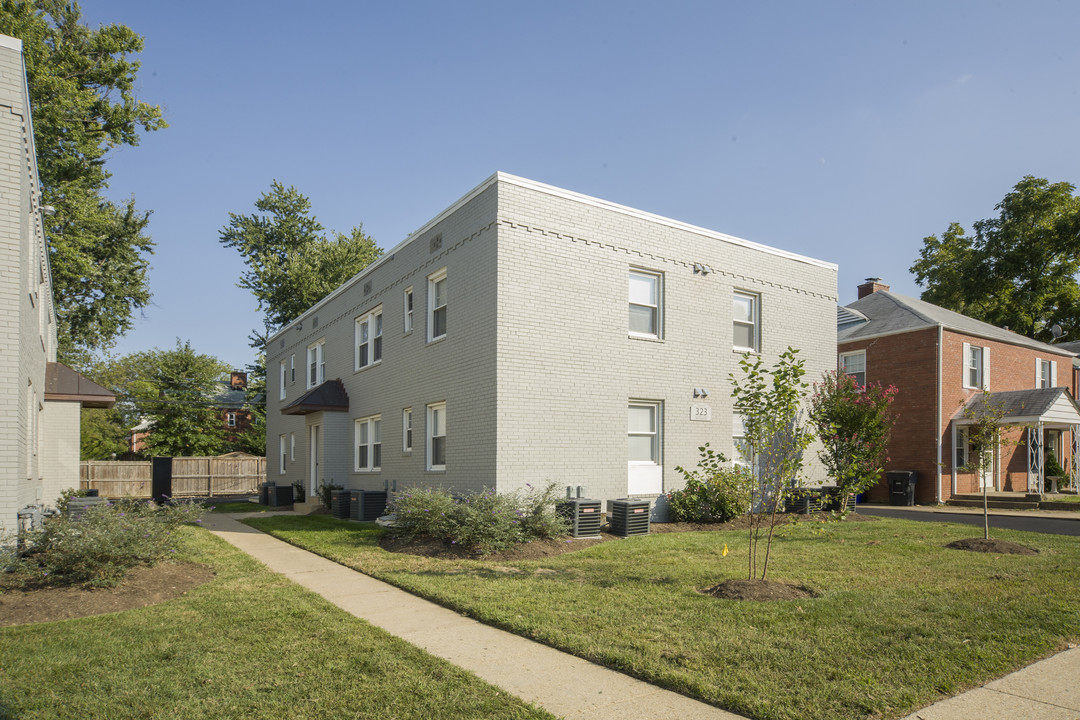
(0, 0), (166, 360)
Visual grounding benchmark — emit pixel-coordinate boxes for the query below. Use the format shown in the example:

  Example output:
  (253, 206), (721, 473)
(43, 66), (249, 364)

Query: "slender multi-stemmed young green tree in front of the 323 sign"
(729, 348), (813, 580)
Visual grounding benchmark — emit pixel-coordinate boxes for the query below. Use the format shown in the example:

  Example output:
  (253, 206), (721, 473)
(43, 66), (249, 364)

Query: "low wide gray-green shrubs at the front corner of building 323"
(389, 483), (567, 555)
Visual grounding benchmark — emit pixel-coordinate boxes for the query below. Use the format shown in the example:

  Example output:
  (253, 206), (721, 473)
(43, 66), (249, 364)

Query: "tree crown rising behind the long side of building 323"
(220, 180), (382, 348)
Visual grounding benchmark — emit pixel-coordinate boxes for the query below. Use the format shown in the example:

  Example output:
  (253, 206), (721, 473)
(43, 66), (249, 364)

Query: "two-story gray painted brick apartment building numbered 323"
(267, 173), (837, 511)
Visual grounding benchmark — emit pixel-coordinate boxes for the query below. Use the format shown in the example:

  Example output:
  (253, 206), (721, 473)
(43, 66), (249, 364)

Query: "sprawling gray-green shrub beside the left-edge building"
(4, 501), (205, 587)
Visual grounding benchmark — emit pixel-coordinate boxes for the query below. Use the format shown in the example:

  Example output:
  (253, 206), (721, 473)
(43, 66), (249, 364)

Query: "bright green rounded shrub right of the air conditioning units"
(666, 443), (753, 522)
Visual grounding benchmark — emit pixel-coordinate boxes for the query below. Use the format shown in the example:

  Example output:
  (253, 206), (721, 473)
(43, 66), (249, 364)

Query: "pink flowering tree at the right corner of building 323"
(810, 371), (896, 514)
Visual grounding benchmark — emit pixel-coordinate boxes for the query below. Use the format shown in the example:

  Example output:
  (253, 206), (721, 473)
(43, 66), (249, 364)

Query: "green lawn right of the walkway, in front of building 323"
(247, 516), (1080, 719)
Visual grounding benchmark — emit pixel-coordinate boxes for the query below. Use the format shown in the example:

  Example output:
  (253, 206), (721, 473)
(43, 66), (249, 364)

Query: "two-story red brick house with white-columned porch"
(837, 277), (1080, 504)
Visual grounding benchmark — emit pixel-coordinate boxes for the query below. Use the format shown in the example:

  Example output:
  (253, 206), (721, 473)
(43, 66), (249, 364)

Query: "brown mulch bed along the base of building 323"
(379, 514), (878, 562)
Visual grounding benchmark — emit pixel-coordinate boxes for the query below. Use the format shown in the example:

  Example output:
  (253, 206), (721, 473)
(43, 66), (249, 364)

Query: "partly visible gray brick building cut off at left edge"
(0, 36), (114, 535)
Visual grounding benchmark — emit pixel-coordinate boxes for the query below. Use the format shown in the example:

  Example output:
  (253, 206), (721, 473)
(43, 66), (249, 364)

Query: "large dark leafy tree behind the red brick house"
(910, 175), (1080, 341)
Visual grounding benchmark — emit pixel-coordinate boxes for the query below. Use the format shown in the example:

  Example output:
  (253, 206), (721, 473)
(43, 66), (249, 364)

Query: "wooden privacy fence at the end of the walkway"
(79, 457), (267, 498)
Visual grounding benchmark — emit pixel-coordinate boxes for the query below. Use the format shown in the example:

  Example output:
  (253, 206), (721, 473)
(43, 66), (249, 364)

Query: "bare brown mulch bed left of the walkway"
(0, 562), (214, 627)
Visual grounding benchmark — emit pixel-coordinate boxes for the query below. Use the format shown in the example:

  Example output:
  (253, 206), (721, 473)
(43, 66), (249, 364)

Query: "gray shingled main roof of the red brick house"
(837, 290), (1076, 355)
